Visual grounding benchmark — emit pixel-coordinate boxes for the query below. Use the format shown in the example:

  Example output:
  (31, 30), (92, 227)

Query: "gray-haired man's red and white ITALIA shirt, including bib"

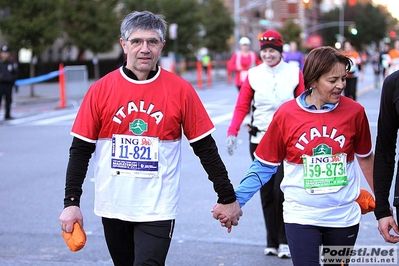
(71, 68), (215, 222)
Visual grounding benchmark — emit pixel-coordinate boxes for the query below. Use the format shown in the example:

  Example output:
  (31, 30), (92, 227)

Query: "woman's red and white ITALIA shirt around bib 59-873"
(255, 97), (372, 227)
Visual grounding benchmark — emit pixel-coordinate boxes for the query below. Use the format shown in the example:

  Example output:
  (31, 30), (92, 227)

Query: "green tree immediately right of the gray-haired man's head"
(121, 0), (234, 60)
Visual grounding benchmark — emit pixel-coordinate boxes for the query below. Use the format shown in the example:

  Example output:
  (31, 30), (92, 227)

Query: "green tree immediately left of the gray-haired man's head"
(61, 0), (119, 79)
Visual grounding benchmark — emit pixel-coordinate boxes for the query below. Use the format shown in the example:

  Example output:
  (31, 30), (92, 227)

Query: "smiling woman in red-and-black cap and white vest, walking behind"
(226, 30), (305, 258)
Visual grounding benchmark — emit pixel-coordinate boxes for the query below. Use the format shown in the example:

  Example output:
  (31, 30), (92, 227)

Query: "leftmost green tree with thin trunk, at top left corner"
(0, 0), (61, 97)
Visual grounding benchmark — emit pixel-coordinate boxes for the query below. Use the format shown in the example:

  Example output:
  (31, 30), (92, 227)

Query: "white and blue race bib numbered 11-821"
(111, 134), (159, 178)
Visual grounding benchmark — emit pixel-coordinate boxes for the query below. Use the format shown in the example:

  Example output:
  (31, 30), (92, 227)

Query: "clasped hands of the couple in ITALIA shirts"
(211, 201), (243, 233)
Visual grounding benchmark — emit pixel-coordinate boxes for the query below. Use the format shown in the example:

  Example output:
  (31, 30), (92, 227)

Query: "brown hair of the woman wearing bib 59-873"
(303, 46), (353, 90)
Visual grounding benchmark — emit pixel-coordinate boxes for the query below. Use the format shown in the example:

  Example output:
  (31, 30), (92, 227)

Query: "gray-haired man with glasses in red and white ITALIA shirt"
(59, 11), (242, 266)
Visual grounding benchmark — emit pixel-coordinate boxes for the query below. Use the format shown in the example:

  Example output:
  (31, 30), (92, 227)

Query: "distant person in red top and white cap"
(227, 37), (262, 91)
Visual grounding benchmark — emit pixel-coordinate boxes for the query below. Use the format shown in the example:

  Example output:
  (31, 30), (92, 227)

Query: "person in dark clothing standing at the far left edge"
(0, 45), (17, 120)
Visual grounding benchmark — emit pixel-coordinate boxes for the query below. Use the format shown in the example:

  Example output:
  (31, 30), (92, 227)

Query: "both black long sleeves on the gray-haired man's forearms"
(64, 135), (236, 208)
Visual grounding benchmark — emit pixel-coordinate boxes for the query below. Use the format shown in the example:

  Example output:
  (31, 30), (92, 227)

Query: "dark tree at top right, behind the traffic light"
(320, 3), (387, 49)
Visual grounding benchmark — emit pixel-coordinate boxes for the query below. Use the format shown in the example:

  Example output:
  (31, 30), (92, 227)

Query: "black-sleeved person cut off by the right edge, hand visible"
(374, 70), (399, 243)
